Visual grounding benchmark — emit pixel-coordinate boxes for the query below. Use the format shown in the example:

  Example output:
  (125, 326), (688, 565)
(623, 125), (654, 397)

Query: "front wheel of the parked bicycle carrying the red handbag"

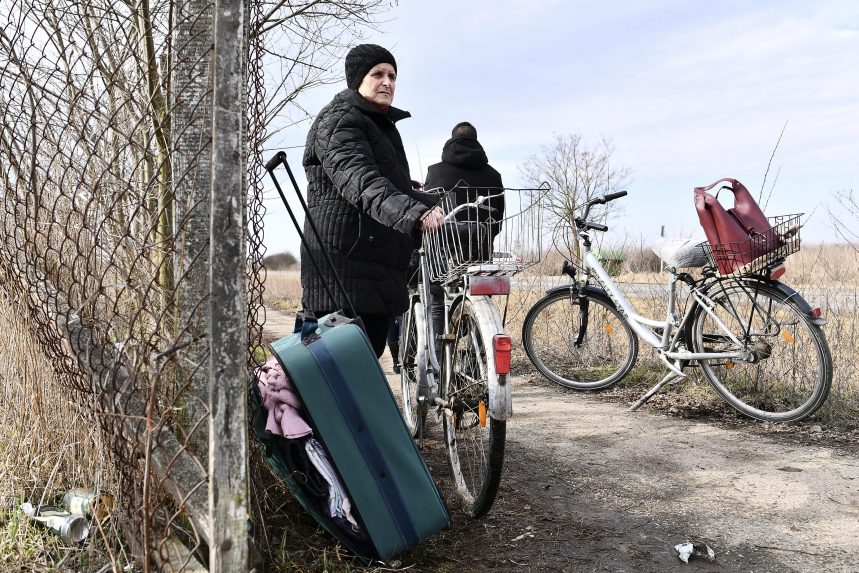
(522, 287), (638, 390)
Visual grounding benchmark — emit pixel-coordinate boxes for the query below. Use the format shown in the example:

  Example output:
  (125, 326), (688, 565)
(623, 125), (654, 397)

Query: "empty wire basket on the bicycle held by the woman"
(423, 186), (546, 283)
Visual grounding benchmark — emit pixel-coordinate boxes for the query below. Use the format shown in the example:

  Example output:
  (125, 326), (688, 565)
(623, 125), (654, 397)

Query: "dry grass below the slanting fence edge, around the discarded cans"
(0, 289), (126, 571)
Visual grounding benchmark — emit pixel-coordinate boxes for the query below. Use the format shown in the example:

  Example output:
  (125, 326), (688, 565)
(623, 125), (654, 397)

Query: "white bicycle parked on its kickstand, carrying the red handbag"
(522, 191), (832, 422)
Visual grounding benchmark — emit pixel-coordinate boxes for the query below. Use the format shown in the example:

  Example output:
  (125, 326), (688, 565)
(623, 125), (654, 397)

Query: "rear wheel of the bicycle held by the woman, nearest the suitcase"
(441, 300), (507, 517)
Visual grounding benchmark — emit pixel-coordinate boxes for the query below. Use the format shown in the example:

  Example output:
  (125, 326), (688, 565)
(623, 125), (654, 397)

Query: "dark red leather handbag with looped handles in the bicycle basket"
(695, 177), (778, 275)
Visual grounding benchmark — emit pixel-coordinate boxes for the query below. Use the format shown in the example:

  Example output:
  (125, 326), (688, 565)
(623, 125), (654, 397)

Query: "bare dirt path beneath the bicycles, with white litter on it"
(266, 311), (859, 572)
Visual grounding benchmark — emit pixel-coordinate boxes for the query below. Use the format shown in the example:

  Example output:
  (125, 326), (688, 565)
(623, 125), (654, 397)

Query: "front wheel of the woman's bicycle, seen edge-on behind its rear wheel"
(400, 302), (429, 438)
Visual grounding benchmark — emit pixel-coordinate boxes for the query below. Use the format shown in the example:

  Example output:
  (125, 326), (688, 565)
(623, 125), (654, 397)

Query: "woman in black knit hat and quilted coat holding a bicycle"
(301, 44), (444, 356)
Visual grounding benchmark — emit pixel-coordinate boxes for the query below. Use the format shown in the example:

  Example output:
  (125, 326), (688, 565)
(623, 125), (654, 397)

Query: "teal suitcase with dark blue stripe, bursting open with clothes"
(254, 313), (450, 561)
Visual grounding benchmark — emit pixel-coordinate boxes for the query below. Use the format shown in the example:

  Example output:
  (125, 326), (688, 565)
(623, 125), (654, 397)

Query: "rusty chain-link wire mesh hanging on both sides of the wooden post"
(0, 0), (268, 571)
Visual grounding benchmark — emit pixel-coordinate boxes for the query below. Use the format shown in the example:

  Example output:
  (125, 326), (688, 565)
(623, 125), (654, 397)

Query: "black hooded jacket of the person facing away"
(424, 137), (504, 228)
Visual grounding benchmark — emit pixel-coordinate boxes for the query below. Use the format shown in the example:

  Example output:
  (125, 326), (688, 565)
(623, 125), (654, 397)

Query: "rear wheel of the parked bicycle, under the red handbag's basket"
(692, 278), (832, 422)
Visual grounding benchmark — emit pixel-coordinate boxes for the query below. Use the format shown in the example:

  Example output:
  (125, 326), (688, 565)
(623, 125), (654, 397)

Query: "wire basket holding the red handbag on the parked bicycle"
(701, 213), (802, 275)
